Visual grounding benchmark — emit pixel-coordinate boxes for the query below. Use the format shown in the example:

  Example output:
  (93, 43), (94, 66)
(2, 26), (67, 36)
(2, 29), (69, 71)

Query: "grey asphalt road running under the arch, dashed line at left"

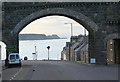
(2, 60), (118, 80)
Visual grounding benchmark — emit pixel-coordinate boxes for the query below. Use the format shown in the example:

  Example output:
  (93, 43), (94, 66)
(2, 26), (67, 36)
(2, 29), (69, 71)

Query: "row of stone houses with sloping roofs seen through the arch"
(61, 35), (88, 62)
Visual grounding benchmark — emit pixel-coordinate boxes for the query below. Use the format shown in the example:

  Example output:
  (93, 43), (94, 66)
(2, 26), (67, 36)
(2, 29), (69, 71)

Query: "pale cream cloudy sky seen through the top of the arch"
(20, 16), (88, 38)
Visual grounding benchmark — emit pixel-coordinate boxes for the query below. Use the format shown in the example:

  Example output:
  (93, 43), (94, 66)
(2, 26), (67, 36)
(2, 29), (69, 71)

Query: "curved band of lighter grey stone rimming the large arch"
(11, 8), (98, 35)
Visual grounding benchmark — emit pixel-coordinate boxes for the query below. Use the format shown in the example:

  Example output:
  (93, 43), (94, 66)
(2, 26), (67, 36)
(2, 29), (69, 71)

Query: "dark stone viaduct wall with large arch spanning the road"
(2, 2), (120, 64)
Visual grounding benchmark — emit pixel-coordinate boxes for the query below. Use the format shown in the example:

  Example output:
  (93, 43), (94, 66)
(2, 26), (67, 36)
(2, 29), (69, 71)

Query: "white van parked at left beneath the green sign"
(8, 53), (21, 67)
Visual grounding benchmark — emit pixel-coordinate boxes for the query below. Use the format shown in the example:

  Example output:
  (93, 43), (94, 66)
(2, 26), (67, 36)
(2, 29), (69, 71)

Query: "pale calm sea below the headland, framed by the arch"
(19, 39), (70, 60)
